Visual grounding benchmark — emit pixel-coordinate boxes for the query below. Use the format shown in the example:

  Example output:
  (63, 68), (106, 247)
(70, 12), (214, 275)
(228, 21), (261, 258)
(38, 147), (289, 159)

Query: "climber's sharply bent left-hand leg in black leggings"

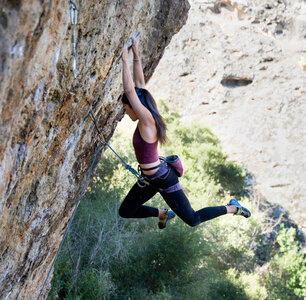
(119, 183), (158, 218)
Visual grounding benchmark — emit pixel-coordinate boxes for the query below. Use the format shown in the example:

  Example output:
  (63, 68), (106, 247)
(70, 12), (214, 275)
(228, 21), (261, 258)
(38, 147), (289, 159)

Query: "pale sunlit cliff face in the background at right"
(148, 0), (306, 233)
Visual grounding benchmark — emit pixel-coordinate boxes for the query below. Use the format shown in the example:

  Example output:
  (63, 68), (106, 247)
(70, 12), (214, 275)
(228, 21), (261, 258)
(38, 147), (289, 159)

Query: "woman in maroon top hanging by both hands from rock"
(119, 38), (251, 229)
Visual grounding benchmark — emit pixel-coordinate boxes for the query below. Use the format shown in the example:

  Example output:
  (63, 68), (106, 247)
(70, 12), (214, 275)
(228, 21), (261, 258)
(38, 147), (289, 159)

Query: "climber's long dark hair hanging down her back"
(122, 88), (167, 144)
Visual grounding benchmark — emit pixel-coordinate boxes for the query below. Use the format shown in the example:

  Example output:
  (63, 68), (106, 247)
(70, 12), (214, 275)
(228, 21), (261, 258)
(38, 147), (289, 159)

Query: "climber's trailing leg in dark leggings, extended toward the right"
(161, 190), (227, 226)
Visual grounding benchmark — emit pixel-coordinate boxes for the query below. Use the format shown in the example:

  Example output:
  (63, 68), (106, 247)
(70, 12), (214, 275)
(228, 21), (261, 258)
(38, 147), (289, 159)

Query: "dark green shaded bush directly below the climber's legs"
(111, 221), (205, 299)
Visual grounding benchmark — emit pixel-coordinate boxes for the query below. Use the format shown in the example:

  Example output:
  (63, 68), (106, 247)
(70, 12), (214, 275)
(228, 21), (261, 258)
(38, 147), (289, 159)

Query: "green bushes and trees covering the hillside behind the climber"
(48, 102), (306, 300)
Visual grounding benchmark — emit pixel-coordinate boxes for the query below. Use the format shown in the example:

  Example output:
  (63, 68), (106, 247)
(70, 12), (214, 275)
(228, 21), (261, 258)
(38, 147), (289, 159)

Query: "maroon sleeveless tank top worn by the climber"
(133, 126), (159, 164)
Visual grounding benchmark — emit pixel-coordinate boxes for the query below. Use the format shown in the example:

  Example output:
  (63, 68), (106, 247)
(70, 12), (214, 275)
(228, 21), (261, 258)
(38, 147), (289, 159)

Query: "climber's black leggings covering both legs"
(119, 169), (227, 226)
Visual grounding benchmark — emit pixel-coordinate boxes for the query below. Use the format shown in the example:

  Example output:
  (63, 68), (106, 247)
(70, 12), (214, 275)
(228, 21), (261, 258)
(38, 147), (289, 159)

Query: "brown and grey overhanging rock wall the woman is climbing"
(0, 0), (189, 299)
